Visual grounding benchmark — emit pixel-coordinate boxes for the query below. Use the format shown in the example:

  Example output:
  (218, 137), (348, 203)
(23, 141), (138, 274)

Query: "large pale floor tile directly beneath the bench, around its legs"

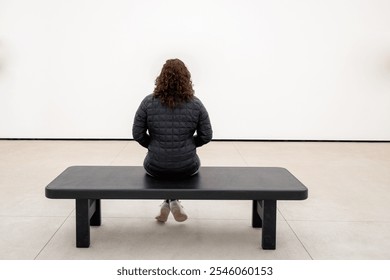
(38, 218), (309, 260)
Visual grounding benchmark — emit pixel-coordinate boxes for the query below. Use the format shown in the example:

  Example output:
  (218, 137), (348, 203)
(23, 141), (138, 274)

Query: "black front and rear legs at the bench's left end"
(76, 199), (101, 248)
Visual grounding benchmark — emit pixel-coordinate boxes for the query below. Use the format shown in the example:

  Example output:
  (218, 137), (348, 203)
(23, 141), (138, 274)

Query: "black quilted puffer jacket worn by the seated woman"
(133, 94), (213, 177)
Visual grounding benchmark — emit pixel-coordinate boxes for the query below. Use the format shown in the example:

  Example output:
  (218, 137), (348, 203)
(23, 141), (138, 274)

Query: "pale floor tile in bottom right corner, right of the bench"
(289, 221), (390, 260)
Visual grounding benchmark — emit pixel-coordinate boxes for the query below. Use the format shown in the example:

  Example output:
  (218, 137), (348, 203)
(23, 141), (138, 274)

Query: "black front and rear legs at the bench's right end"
(252, 200), (276, 250)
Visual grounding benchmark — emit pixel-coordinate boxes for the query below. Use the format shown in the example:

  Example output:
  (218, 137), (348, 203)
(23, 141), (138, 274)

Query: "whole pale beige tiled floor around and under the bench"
(0, 141), (390, 260)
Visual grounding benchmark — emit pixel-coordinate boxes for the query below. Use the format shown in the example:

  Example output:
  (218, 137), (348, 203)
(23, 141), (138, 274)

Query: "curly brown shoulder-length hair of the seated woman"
(153, 58), (194, 108)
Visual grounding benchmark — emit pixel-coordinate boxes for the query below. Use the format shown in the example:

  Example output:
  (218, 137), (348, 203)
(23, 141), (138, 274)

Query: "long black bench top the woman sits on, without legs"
(45, 166), (308, 200)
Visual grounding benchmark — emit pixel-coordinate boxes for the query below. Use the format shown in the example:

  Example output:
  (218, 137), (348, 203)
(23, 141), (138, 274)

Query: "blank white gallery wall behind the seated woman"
(0, 0), (390, 140)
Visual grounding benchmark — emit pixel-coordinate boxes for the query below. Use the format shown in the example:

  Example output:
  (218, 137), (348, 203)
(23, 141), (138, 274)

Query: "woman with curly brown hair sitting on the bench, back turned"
(133, 59), (213, 222)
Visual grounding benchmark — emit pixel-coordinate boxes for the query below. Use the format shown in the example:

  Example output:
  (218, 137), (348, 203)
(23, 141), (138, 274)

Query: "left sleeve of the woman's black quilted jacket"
(133, 98), (150, 148)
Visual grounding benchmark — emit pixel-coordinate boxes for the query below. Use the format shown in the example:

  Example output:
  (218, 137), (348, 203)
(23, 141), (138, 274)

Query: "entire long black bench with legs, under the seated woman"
(45, 166), (308, 249)
